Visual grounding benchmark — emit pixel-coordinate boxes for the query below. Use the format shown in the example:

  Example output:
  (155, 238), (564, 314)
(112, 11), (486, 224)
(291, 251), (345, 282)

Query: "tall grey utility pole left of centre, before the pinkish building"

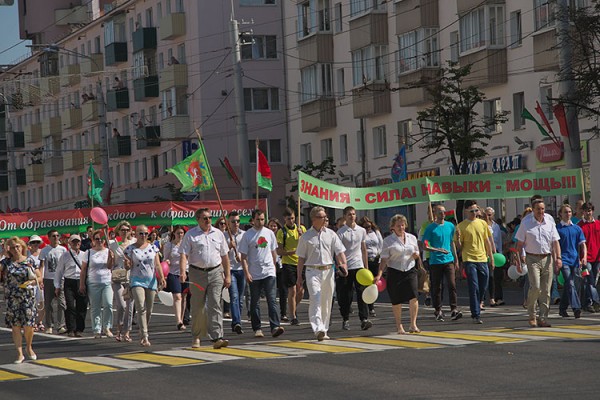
(230, 11), (250, 199)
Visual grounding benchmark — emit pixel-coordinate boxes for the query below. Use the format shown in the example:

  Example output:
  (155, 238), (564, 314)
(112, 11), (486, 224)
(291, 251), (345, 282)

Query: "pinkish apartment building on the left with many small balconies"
(0, 0), (289, 215)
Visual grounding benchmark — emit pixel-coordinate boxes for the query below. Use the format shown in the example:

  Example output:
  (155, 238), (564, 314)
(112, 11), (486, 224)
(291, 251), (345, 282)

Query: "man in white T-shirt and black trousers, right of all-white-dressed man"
(335, 206), (373, 331)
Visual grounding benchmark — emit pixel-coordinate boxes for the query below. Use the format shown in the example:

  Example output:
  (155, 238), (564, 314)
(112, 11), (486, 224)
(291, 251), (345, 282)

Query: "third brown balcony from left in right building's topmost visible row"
(395, 0), (440, 35)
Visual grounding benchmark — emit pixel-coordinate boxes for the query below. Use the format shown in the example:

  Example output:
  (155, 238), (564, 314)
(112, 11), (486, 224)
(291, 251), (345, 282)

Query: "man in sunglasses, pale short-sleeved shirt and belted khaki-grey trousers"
(179, 208), (231, 349)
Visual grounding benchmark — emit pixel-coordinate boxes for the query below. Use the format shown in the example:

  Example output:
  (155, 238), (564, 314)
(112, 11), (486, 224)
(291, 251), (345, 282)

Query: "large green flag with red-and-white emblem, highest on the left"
(166, 142), (213, 192)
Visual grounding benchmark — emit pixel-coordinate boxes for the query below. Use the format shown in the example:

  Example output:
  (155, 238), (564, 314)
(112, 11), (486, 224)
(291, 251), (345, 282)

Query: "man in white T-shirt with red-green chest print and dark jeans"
(239, 210), (284, 337)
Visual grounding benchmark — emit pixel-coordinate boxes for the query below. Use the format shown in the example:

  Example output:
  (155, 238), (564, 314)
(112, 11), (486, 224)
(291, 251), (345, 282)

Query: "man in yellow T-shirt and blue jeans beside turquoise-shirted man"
(456, 200), (494, 324)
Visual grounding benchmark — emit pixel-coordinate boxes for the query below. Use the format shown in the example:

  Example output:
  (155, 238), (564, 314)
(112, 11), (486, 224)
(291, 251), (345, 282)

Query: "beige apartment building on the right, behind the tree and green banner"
(284, 0), (600, 230)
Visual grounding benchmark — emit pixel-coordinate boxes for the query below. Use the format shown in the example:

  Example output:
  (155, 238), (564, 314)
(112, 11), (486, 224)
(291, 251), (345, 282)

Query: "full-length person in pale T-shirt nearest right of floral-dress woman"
(40, 229), (67, 334)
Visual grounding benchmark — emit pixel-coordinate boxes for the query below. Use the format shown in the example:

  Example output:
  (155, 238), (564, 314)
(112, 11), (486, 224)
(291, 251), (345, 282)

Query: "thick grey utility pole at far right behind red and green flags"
(556, 0), (582, 204)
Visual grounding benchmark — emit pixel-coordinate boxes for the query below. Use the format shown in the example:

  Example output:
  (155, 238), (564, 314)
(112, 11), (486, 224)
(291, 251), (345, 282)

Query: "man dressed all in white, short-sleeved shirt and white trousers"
(296, 207), (348, 341)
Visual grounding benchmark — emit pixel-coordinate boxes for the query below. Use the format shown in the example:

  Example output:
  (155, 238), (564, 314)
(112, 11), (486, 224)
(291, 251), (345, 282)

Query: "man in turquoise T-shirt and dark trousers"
(423, 205), (462, 322)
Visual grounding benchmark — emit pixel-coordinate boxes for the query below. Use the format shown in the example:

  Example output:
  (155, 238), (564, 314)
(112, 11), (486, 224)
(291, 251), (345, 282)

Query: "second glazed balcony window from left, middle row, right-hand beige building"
(352, 45), (387, 86)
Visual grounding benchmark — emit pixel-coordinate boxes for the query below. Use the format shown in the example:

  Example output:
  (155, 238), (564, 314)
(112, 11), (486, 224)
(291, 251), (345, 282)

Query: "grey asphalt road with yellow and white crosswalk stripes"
(0, 284), (600, 399)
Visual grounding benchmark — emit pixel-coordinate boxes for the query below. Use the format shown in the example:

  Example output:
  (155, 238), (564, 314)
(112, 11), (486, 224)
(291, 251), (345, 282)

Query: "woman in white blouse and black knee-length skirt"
(375, 214), (421, 334)
